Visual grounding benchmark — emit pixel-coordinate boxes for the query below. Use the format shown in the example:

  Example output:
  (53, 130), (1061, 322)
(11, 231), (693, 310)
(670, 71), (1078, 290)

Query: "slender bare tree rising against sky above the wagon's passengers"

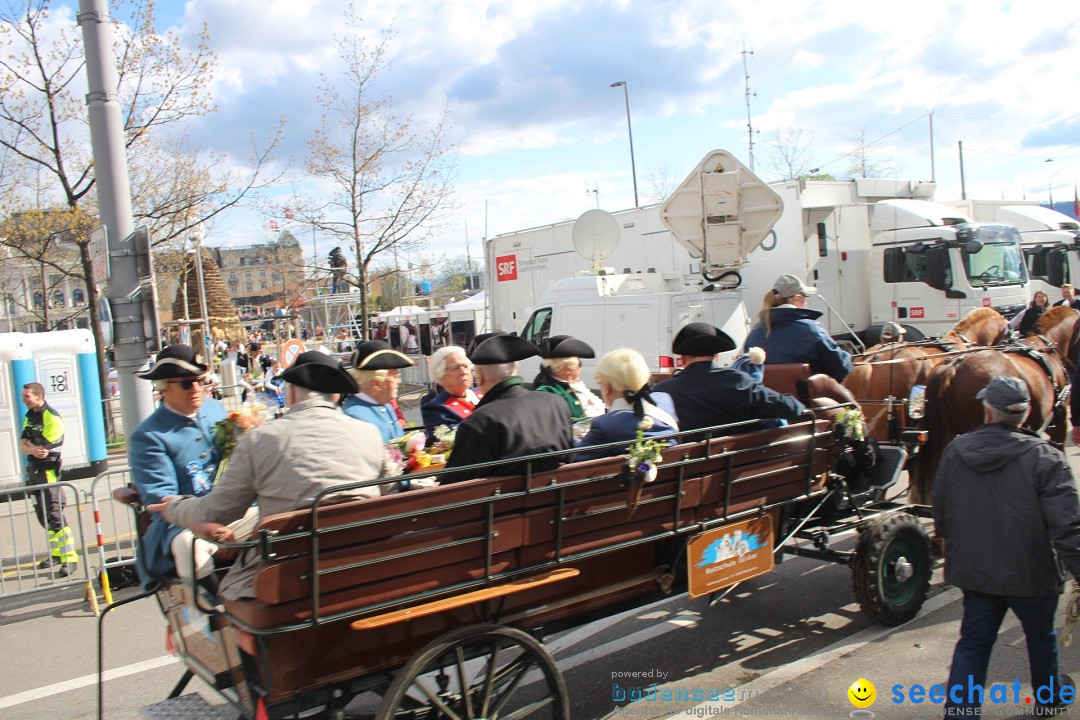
(307, 5), (454, 337)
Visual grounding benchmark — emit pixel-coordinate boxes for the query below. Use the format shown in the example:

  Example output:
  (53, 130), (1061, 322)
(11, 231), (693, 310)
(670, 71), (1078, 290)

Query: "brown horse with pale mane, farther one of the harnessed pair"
(843, 308), (1008, 439)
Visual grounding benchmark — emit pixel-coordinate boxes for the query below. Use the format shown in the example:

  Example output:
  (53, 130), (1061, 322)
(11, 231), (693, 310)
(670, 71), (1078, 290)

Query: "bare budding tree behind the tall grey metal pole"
(0, 0), (282, 390)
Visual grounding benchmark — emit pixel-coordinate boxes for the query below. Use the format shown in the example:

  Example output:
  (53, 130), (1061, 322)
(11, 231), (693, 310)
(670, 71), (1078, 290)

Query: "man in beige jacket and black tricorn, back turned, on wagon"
(148, 351), (393, 600)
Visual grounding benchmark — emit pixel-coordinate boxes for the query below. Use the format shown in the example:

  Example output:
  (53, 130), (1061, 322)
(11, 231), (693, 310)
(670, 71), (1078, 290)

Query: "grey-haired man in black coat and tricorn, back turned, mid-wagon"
(441, 335), (573, 485)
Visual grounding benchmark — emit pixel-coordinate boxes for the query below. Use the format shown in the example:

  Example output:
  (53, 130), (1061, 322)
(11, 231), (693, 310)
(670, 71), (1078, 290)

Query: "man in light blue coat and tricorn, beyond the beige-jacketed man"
(341, 340), (416, 443)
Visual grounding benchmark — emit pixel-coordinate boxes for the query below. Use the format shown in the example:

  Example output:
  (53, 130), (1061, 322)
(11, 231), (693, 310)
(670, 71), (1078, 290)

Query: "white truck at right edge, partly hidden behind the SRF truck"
(948, 200), (1080, 302)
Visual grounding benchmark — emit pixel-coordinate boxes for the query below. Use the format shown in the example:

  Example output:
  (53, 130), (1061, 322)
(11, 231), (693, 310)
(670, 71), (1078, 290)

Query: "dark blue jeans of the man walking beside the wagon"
(945, 590), (1061, 717)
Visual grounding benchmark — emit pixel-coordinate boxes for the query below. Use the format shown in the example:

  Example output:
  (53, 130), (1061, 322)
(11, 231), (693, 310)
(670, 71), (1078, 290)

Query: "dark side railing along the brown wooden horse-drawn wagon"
(206, 405), (834, 635)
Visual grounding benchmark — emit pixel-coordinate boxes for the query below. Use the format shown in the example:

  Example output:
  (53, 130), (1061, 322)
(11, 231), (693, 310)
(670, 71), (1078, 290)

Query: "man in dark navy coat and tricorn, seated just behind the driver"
(656, 323), (806, 433)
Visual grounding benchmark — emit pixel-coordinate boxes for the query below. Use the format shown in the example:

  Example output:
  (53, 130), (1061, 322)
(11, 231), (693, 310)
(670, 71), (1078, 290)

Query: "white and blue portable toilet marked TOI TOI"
(0, 329), (108, 487)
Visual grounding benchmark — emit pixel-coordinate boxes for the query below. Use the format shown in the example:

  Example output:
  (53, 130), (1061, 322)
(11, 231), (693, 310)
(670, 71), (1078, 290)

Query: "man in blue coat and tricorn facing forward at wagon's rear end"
(127, 344), (226, 584)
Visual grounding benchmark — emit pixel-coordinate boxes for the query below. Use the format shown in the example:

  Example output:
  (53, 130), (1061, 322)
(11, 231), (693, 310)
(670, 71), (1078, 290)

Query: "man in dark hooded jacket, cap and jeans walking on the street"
(933, 377), (1080, 717)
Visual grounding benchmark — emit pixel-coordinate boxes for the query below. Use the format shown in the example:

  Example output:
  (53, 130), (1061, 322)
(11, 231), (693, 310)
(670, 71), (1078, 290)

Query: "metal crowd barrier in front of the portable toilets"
(0, 466), (136, 611)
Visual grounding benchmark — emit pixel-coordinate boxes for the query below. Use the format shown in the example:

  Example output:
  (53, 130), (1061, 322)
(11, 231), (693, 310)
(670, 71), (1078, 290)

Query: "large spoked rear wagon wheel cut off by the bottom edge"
(375, 625), (570, 720)
